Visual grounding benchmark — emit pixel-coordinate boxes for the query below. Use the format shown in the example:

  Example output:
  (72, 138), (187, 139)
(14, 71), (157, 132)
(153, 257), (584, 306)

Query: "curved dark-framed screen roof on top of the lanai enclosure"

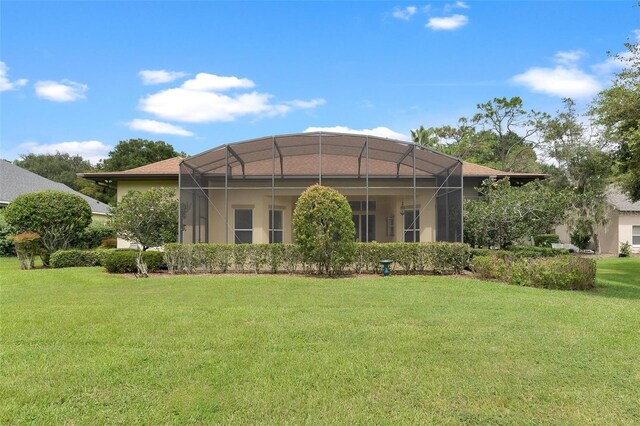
(182, 132), (462, 177)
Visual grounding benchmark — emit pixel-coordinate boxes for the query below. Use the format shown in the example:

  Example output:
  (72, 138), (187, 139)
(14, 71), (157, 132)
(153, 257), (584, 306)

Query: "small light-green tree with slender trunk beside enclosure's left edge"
(111, 188), (178, 277)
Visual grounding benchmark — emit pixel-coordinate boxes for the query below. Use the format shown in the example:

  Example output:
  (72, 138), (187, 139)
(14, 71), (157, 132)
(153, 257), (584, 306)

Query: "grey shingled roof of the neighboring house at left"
(0, 160), (109, 215)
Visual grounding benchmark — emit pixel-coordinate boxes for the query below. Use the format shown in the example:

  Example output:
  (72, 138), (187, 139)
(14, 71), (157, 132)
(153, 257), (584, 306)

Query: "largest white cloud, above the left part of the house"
(139, 73), (325, 123)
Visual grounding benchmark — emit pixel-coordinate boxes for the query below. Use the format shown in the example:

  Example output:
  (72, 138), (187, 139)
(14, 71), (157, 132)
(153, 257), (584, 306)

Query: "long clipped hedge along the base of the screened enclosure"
(164, 242), (470, 274)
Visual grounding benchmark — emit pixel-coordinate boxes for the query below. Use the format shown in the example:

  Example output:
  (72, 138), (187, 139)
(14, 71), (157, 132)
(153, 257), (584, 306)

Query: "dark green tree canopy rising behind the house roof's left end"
(98, 139), (187, 171)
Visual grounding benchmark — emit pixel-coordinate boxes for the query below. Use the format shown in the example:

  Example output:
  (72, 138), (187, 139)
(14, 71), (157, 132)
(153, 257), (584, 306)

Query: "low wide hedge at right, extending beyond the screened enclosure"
(471, 256), (596, 290)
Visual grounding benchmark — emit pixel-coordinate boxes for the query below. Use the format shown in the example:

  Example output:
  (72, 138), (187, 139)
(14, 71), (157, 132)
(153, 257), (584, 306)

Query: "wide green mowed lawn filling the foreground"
(0, 258), (640, 424)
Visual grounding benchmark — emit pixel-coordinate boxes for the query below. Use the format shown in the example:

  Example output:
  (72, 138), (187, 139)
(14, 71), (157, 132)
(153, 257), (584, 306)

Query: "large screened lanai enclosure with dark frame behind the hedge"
(179, 132), (463, 243)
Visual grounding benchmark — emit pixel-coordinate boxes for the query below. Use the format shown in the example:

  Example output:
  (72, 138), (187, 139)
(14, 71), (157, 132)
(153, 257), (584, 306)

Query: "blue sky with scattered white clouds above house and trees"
(0, 0), (640, 163)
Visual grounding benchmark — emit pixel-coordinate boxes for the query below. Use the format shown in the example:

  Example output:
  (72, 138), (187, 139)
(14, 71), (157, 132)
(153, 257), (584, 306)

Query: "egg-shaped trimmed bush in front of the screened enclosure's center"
(293, 185), (356, 275)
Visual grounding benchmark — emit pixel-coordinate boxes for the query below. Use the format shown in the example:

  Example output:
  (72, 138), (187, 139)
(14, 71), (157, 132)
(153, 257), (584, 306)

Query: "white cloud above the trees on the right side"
(512, 65), (602, 98)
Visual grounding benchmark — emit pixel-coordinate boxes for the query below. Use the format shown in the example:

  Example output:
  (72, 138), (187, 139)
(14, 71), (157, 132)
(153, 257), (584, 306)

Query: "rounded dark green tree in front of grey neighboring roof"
(5, 191), (91, 266)
